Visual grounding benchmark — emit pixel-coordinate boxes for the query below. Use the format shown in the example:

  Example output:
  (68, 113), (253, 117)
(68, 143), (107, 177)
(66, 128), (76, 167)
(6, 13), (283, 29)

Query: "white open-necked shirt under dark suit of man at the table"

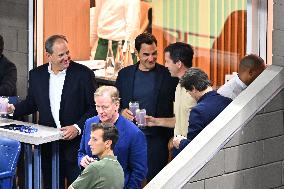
(48, 63), (66, 128)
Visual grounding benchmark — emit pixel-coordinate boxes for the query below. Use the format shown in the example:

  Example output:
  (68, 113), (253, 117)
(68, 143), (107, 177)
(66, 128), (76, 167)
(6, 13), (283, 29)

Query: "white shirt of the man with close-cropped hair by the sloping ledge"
(217, 75), (247, 100)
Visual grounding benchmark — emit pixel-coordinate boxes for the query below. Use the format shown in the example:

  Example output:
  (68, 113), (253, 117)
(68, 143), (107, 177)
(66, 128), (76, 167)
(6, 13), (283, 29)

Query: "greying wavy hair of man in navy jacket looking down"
(180, 68), (211, 91)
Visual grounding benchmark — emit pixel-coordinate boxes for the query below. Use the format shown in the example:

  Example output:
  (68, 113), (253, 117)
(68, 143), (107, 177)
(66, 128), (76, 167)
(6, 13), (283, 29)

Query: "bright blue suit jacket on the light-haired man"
(78, 116), (147, 189)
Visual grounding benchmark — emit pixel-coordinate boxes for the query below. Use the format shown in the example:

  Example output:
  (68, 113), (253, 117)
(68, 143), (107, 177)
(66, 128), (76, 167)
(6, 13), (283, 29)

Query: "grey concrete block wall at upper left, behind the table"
(0, 0), (28, 98)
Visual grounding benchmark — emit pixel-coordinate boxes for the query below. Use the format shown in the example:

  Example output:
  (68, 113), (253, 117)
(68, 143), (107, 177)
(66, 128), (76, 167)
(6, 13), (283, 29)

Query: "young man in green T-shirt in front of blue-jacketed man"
(68, 123), (124, 189)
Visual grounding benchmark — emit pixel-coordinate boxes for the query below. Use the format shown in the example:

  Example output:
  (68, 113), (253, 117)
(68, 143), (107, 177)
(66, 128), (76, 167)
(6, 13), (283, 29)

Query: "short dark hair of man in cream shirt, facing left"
(164, 42), (194, 68)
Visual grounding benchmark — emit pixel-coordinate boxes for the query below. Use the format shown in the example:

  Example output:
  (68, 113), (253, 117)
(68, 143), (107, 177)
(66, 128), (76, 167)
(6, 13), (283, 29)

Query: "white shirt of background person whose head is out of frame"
(91, 0), (141, 52)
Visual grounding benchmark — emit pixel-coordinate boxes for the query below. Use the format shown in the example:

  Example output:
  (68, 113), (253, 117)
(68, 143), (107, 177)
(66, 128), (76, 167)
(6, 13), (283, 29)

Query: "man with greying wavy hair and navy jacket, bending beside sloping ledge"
(173, 68), (232, 154)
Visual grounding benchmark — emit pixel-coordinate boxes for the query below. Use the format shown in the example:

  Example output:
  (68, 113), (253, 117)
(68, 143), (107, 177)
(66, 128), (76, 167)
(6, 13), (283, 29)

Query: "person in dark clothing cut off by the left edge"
(0, 35), (17, 96)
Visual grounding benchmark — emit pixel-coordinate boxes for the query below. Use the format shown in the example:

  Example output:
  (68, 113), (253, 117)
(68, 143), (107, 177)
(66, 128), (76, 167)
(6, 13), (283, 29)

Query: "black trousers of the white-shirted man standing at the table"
(41, 143), (81, 189)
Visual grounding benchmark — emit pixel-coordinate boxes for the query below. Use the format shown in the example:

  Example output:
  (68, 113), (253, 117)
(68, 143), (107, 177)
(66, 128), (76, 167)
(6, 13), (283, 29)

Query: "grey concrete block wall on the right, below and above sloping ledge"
(183, 0), (284, 189)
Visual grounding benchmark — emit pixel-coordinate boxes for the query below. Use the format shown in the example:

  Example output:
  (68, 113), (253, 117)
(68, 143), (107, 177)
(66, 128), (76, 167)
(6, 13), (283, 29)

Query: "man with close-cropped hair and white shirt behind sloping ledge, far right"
(217, 54), (266, 100)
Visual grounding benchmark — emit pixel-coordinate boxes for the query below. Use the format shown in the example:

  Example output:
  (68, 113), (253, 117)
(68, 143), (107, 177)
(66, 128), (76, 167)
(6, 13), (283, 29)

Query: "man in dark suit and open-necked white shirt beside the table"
(7, 35), (96, 188)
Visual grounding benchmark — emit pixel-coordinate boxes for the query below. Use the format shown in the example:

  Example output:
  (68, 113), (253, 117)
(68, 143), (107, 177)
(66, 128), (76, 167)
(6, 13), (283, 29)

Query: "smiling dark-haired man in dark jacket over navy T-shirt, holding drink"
(116, 33), (178, 182)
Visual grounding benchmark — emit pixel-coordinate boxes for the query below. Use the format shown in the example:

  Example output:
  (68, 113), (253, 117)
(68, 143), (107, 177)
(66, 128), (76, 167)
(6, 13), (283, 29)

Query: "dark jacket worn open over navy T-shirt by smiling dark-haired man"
(116, 62), (178, 136)
